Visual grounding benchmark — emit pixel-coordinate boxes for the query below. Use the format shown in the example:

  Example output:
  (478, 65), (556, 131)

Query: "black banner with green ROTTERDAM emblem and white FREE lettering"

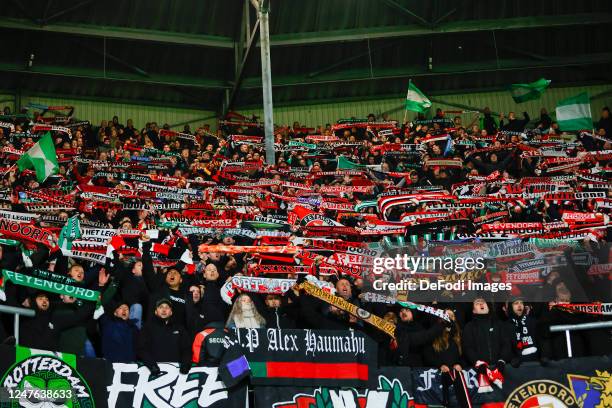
(0, 345), (248, 408)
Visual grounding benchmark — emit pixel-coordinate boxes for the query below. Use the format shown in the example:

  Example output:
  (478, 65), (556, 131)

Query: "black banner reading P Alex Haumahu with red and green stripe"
(230, 329), (378, 387)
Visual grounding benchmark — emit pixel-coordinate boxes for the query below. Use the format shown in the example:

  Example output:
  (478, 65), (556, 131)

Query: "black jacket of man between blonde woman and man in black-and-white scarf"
(462, 315), (512, 365)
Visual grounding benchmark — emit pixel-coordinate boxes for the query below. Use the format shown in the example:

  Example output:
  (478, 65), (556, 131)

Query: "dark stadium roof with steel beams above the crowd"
(0, 0), (612, 112)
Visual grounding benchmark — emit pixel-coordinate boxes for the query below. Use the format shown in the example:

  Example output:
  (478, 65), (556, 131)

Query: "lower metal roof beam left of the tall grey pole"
(0, 63), (229, 89)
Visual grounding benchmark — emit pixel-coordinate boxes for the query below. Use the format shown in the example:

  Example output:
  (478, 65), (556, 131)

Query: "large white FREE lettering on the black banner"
(106, 363), (228, 408)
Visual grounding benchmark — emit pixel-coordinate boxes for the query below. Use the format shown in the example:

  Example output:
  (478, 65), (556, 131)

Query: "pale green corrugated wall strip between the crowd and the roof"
(0, 84), (612, 129)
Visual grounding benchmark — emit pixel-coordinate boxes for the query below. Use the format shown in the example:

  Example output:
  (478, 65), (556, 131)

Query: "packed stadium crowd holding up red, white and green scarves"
(0, 103), (612, 396)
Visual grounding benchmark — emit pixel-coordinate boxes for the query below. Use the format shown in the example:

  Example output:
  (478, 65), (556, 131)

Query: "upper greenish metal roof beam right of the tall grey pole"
(270, 13), (612, 46)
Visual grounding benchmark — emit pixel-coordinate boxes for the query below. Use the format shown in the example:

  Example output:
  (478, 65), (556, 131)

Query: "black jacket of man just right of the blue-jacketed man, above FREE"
(136, 316), (191, 367)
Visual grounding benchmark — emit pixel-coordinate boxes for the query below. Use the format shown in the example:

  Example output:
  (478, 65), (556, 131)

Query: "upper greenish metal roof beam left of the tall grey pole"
(0, 17), (234, 49)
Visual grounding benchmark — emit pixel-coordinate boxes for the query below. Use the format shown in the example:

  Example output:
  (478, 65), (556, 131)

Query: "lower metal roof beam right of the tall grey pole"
(243, 52), (612, 89)
